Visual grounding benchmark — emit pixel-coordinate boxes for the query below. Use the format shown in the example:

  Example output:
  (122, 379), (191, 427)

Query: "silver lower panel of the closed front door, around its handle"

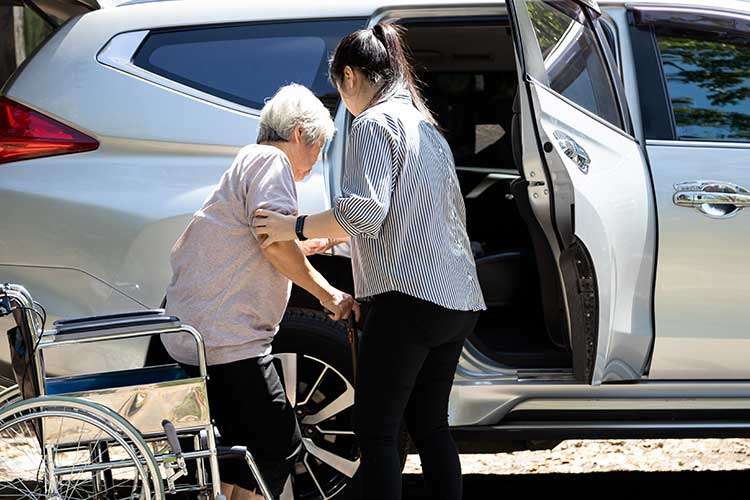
(647, 141), (750, 379)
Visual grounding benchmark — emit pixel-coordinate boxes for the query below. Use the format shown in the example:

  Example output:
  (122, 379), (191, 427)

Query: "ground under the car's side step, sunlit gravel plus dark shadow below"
(404, 439), (750, 500)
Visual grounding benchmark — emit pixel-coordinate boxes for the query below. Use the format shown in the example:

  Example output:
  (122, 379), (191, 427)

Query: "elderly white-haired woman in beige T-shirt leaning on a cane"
(162, 85), (358, 500)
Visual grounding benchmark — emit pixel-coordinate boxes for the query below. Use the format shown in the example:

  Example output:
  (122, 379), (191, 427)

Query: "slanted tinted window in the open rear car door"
(526, 0), (622, 127)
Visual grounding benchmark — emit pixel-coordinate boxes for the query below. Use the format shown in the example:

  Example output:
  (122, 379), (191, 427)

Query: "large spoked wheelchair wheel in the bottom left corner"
(0, 397), (164, 500)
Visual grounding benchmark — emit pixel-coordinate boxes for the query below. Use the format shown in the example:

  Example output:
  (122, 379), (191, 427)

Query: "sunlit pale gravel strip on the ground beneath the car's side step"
(404, 439), (750, 475)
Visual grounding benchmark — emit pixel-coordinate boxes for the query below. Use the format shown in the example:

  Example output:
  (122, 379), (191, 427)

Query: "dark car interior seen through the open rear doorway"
(402, 17), (571, 369)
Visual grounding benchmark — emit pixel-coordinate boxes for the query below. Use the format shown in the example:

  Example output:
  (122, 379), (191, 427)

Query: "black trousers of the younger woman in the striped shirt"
(354, 292), (479, 500)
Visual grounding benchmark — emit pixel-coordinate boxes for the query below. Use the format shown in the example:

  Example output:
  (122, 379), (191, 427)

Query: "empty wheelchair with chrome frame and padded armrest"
(0, 284), (273, 500)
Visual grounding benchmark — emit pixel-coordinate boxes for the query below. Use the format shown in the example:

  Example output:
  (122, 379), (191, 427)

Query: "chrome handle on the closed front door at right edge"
(672, 181), (750, 219)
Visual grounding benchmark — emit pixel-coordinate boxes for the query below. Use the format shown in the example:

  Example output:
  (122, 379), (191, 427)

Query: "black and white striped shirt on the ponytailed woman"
(333, 91), (485, 311)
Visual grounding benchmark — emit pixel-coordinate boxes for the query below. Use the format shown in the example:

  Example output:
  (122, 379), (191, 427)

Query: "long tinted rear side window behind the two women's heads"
(135, 19), (364, 109)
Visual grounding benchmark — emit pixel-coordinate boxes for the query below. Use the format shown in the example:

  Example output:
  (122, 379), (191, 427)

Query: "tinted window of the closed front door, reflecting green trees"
(657, 29), (750, 141)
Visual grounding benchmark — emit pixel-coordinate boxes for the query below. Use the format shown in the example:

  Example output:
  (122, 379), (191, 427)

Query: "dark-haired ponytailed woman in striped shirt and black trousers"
(254, 24), (485, 500)
